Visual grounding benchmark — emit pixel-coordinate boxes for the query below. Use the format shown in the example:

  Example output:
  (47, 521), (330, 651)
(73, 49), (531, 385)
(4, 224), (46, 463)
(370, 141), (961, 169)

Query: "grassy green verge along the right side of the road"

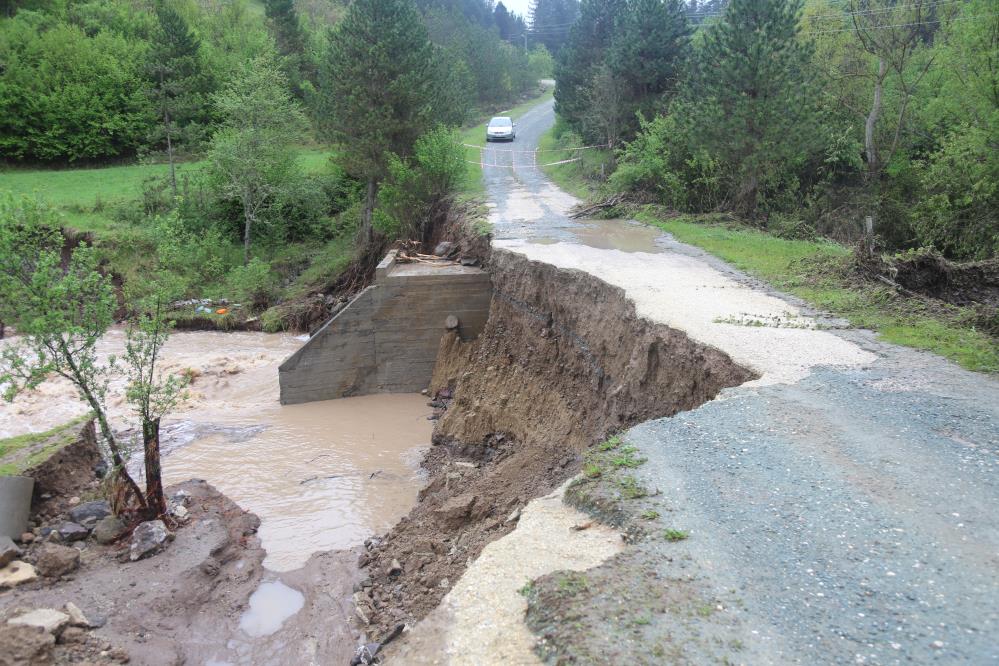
(542, 125), (999, 373)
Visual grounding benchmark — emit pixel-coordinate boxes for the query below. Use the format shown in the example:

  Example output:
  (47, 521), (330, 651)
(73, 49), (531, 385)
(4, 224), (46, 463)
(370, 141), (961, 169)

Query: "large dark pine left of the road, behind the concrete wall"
(321, 0), (439, 242)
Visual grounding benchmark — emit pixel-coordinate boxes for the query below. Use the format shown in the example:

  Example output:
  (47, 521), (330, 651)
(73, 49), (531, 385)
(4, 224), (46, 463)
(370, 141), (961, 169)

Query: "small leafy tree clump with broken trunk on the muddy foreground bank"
(0, 196), (180, 517)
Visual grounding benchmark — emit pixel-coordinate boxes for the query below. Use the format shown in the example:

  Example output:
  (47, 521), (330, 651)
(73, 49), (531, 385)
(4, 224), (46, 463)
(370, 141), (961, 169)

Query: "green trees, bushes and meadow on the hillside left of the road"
(0, 0), (552, 330)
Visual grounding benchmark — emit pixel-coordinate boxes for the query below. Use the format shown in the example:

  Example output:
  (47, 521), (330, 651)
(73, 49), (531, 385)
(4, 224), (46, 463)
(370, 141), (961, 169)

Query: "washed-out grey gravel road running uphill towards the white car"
(484, 103), (999, 664)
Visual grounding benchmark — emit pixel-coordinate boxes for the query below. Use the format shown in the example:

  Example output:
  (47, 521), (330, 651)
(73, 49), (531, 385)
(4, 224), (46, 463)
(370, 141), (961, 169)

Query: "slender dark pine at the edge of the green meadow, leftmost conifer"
(147, 2), (212, 197)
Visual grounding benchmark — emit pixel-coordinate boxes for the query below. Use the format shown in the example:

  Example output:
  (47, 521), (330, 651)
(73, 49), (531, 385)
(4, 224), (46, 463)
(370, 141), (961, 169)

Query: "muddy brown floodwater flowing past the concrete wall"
(0, 330), (432, 571)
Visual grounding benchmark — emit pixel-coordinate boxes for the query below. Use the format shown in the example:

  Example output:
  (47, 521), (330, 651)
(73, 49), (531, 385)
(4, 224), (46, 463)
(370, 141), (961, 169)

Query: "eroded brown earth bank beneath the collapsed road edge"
(357, 250), (754, 637)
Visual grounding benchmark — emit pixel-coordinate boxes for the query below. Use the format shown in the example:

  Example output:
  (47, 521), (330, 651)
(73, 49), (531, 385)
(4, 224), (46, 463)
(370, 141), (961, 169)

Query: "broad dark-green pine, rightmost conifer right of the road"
(691, 0), (814, 215)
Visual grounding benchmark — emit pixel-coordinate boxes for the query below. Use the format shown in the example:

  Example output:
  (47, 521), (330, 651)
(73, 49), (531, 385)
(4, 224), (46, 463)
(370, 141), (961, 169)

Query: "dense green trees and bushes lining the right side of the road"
(555, 0), (999, 260)
